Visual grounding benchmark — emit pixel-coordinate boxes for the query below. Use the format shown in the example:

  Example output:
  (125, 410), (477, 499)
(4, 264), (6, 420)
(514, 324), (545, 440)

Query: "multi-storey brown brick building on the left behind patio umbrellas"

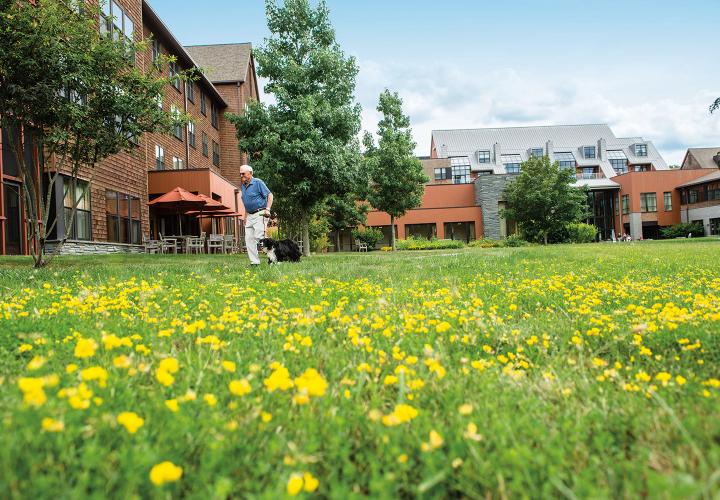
(0, 0), (259, 254)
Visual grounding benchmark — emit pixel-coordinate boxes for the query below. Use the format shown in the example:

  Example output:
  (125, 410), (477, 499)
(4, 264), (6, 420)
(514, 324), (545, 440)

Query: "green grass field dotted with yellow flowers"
(0, 240), (720, 499)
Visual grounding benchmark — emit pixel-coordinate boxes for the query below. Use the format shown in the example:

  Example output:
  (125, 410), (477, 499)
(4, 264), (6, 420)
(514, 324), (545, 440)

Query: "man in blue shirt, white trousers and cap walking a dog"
(240, 165), (273, 266)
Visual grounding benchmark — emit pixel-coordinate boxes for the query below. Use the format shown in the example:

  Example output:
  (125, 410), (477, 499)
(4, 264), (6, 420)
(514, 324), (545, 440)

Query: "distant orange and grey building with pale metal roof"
(368, 124), (720, 244)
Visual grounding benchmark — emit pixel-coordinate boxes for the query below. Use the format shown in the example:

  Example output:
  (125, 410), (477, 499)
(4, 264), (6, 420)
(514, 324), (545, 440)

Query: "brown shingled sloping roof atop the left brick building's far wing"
(185, 43), (252, 83)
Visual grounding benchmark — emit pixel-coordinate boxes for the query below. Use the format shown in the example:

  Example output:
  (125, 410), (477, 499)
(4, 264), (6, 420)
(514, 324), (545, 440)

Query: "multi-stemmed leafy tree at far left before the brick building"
(0, 0), (189, 267)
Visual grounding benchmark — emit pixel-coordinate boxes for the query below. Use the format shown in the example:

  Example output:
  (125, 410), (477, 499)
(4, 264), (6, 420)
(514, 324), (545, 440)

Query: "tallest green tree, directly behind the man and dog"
(228, 0), (361, 255)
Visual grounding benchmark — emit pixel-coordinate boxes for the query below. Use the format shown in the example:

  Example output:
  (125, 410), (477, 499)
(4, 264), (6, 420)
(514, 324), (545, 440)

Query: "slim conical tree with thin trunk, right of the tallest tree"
(363, 89), (429, 250)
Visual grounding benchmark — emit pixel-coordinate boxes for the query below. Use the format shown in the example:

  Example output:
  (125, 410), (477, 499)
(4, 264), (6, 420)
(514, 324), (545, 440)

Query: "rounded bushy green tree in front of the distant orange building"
(502, 156), (587, 245)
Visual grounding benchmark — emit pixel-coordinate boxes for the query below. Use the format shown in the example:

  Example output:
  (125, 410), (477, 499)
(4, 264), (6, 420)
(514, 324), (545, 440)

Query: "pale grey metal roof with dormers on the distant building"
(432, 124), (668, 184)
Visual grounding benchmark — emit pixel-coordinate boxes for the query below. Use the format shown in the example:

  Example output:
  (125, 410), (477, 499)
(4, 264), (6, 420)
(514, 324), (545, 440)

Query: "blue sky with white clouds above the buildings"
(150, 0), (720, 164)
